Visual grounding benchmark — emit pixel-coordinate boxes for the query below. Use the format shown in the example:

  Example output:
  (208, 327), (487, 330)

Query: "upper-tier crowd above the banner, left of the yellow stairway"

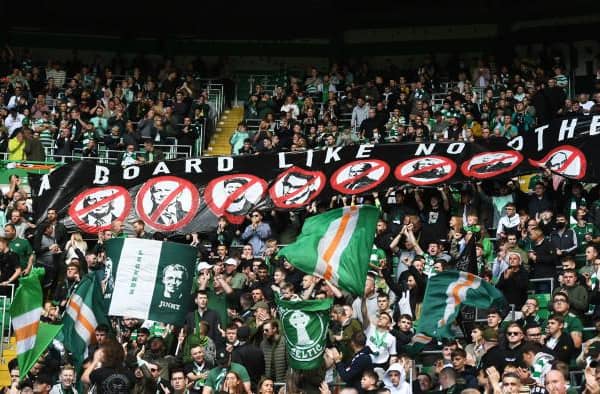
(0, 49), (215, 166)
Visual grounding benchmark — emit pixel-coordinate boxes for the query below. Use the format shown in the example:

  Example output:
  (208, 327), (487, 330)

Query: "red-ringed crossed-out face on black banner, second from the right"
(461, 150), (523, 179)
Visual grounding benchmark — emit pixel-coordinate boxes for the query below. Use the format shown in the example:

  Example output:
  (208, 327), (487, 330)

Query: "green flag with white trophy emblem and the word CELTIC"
(275, 297), (333, 370)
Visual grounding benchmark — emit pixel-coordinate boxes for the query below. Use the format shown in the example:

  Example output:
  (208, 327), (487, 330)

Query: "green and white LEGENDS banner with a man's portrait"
(106, 238), (198, 326)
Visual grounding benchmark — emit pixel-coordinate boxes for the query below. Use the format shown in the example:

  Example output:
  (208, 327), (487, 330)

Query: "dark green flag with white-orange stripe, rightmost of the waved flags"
(418, 270), (506, 338)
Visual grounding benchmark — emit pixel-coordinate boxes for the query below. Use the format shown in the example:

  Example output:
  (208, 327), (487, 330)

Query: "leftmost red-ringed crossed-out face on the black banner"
(69, 186), (131, 234)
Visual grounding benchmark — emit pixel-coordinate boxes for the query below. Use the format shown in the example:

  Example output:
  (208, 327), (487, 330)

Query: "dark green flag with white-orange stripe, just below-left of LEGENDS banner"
(62, 274), (110, 368)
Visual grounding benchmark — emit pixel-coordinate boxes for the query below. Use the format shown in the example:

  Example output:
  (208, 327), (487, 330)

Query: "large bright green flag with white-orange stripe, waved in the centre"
(279, 205), (379, 296)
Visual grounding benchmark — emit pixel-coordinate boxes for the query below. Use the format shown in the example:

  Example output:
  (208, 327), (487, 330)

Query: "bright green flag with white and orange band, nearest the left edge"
(10, 268), (62, 378)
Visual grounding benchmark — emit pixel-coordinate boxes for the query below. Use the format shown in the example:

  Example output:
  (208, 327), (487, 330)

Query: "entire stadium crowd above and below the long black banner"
(0, 43), (600, 394)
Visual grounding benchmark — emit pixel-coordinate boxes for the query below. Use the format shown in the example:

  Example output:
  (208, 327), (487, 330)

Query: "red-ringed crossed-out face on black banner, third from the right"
(394, 156), (457, 186)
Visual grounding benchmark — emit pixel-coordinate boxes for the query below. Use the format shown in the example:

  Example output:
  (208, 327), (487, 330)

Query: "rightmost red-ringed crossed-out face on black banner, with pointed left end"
(529, 145), (587, 179)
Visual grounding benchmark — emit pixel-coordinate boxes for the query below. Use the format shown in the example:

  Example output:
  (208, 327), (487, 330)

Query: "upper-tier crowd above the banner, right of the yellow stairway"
(230, 59), (600, 154)
